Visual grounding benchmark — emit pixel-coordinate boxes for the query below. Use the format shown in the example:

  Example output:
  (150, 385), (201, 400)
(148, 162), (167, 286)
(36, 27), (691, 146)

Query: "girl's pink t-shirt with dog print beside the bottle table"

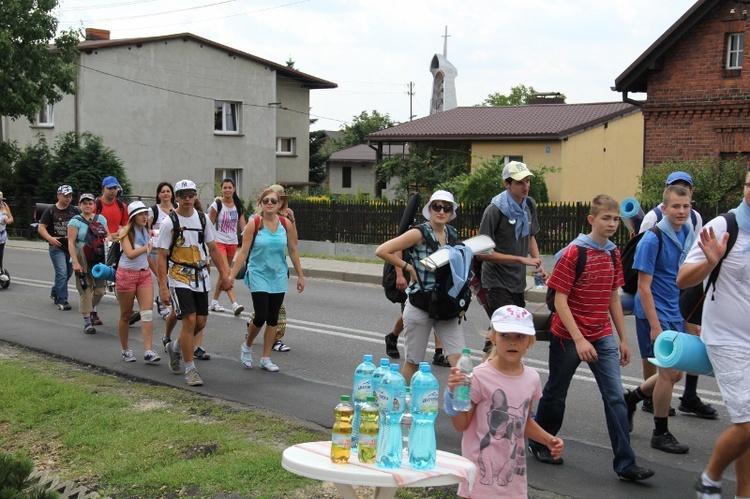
(458, 362), (542, 499)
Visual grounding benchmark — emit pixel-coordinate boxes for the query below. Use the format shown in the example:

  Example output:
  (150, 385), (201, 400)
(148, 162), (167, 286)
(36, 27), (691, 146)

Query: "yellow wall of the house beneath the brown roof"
(471, 112), (643, 202)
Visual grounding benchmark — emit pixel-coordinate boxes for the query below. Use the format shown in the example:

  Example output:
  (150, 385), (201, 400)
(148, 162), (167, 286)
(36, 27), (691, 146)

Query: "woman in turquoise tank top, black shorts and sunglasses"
(231, 187), (305, 372)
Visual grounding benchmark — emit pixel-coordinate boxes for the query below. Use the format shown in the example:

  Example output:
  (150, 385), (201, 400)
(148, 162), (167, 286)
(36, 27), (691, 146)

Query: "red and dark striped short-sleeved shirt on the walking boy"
(547, 245), (624, 341)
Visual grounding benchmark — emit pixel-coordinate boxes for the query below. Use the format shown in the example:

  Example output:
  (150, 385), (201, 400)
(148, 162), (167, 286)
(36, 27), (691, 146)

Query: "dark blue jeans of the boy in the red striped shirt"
(530, 335), (635, 475)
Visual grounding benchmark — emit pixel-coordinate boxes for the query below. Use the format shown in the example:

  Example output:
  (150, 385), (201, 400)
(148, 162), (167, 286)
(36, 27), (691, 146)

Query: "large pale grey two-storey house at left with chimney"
(0, 29), (337, 202)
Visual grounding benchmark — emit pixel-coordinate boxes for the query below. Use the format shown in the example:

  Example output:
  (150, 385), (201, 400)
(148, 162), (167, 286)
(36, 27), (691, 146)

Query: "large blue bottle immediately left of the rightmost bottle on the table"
(375, 364), (406, 468)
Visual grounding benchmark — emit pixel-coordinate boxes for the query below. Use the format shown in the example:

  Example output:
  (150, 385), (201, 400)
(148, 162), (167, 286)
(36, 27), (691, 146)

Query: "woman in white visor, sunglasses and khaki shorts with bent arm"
(375, 191), (466, 383)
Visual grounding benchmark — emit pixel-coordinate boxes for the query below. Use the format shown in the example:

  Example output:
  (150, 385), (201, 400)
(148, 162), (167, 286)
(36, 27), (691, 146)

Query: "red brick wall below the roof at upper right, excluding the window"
(643, 1), (750, 165)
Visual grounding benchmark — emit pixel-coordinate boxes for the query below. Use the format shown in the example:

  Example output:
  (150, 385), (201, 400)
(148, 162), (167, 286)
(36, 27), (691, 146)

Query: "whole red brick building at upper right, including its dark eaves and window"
(615, 0), (750, 166)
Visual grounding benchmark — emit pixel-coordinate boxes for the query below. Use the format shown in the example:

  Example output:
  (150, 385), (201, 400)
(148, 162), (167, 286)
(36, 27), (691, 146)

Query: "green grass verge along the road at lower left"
(0, 343), (455, 498)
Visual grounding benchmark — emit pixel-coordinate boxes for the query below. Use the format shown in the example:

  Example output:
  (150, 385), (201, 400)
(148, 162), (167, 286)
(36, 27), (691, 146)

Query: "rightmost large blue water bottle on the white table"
(409, 362), (440, 470)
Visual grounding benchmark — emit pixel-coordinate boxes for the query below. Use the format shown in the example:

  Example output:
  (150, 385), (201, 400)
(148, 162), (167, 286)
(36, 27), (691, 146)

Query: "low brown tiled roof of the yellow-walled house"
(367, 102), (639, 142)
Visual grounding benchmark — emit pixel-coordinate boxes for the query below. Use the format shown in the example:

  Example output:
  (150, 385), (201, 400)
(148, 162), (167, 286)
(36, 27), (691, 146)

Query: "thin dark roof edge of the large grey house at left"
(77, 33), (338, 88)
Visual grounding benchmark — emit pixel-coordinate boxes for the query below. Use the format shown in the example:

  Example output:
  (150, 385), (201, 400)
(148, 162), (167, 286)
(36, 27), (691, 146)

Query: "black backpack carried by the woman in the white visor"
(409, 222), (471, 323)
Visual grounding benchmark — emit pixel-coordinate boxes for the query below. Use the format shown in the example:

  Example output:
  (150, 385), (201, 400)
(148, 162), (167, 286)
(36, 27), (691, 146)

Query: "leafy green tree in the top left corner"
(0, 0), (80, 122)
